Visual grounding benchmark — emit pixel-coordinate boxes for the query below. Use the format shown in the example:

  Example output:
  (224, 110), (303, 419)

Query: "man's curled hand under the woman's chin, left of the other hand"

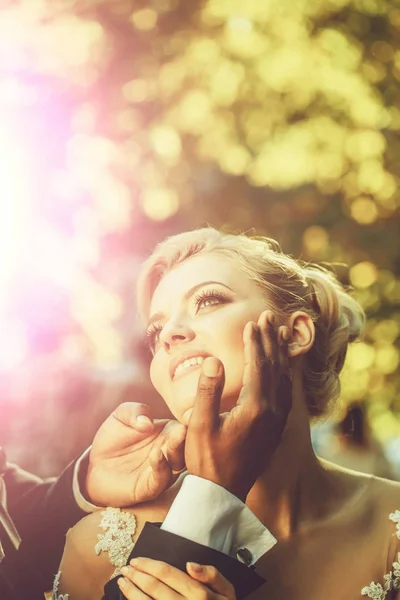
(86, 402), (186, 507)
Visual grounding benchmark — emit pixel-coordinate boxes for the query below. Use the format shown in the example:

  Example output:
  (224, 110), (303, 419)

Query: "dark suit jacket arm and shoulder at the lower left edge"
(0, 458), (85, 600)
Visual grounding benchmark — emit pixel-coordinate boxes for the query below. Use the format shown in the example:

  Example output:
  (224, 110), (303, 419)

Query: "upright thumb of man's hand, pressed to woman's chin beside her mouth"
(189, 356), (224, 432)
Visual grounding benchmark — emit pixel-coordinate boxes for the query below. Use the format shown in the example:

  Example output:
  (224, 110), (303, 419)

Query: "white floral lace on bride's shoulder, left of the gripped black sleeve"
(94, 508), (136, 580)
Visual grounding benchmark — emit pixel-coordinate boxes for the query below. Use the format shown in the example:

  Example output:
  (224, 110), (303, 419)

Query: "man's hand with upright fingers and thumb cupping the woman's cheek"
(185, 311), (292, 501)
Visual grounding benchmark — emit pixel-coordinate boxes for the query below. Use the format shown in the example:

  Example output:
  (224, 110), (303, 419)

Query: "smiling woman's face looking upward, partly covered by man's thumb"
(147, 253), (271, 424)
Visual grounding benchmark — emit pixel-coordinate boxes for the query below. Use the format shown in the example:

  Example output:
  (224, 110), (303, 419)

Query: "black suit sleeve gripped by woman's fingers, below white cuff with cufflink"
(104, 523), (265, 600)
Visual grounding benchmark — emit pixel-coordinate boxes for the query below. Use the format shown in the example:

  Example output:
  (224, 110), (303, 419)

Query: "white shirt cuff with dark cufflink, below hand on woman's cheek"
(161, 475), (276, 565)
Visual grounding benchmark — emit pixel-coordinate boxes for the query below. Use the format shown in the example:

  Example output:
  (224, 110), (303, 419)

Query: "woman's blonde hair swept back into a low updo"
(138, 227), (365, 417)
